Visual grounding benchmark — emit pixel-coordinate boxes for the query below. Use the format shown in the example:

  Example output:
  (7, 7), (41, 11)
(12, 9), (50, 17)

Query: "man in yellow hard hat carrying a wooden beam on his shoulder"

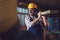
(25, 3), (48, 40)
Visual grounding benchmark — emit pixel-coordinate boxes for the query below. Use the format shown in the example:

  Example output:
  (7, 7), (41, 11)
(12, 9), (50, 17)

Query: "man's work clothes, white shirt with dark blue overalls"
(25, 16), (44, 40)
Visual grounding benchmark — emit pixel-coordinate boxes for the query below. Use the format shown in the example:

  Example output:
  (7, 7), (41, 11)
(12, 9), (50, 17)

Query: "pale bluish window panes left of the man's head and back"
(17, 7), (28, 26)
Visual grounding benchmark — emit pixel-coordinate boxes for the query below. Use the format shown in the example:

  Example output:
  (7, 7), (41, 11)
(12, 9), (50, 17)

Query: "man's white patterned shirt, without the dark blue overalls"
(25, 16), (43, 30)
